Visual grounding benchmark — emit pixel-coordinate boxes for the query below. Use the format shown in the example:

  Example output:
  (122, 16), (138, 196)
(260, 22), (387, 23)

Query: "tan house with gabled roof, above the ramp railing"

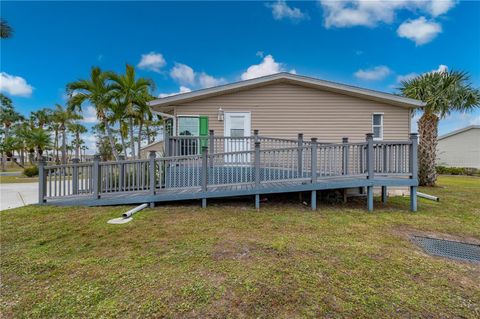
(149, 73), (424, 148)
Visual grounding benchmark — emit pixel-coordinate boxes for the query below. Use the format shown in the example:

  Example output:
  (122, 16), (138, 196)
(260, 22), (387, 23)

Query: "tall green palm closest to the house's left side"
(108, 64), (153, 158)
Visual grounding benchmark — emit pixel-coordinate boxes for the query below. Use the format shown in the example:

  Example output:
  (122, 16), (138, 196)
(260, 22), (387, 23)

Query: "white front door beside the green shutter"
(224, 112), (251, 162)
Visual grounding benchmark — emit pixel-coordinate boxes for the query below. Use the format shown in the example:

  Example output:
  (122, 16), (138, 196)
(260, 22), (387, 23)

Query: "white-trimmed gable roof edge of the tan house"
(149, 72), (425, 109)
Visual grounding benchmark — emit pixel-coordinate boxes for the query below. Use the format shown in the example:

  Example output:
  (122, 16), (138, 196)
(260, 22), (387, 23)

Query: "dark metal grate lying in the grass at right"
(412, 236), (480, 262)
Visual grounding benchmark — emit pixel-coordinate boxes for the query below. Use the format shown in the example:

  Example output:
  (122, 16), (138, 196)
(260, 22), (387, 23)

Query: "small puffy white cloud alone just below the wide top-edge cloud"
(397, 17), (442, 45)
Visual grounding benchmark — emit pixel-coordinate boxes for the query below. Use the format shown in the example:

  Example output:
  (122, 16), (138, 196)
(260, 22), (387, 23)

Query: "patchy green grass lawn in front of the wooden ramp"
(0, 177), (480, 318)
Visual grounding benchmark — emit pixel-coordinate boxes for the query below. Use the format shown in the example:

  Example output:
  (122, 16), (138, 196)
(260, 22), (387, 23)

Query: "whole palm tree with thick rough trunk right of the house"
(400, 71), (480, 186)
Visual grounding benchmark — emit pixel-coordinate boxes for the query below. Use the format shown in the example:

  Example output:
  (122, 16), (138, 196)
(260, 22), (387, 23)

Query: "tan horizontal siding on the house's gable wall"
(175, 84), (410, 142)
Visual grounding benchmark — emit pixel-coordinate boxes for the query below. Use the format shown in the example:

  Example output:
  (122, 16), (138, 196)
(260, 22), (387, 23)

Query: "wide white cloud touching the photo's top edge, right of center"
(319, 0), (456, 28)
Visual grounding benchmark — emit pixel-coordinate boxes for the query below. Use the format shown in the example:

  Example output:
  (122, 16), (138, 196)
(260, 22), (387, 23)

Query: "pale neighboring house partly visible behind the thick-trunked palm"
(437, 125), (480, 169)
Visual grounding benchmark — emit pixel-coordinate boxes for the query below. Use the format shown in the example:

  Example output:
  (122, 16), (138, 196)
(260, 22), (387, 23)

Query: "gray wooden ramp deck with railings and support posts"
(39, 135), (418, 211)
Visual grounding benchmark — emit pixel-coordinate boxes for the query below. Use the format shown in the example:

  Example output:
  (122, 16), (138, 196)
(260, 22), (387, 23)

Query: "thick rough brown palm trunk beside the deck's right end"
(418, 113), (439, 186)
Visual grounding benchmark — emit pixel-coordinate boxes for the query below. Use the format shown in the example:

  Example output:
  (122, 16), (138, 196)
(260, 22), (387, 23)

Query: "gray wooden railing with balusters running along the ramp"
(39, 134), (417, 203)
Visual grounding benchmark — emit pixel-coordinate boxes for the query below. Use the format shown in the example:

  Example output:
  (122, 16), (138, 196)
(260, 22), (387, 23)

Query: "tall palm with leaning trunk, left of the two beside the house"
(67, 67), (118, 160)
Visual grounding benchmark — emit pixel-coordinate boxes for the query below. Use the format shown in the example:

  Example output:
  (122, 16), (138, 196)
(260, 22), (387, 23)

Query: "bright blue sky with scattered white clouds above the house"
(0, 0), (480, 151)
